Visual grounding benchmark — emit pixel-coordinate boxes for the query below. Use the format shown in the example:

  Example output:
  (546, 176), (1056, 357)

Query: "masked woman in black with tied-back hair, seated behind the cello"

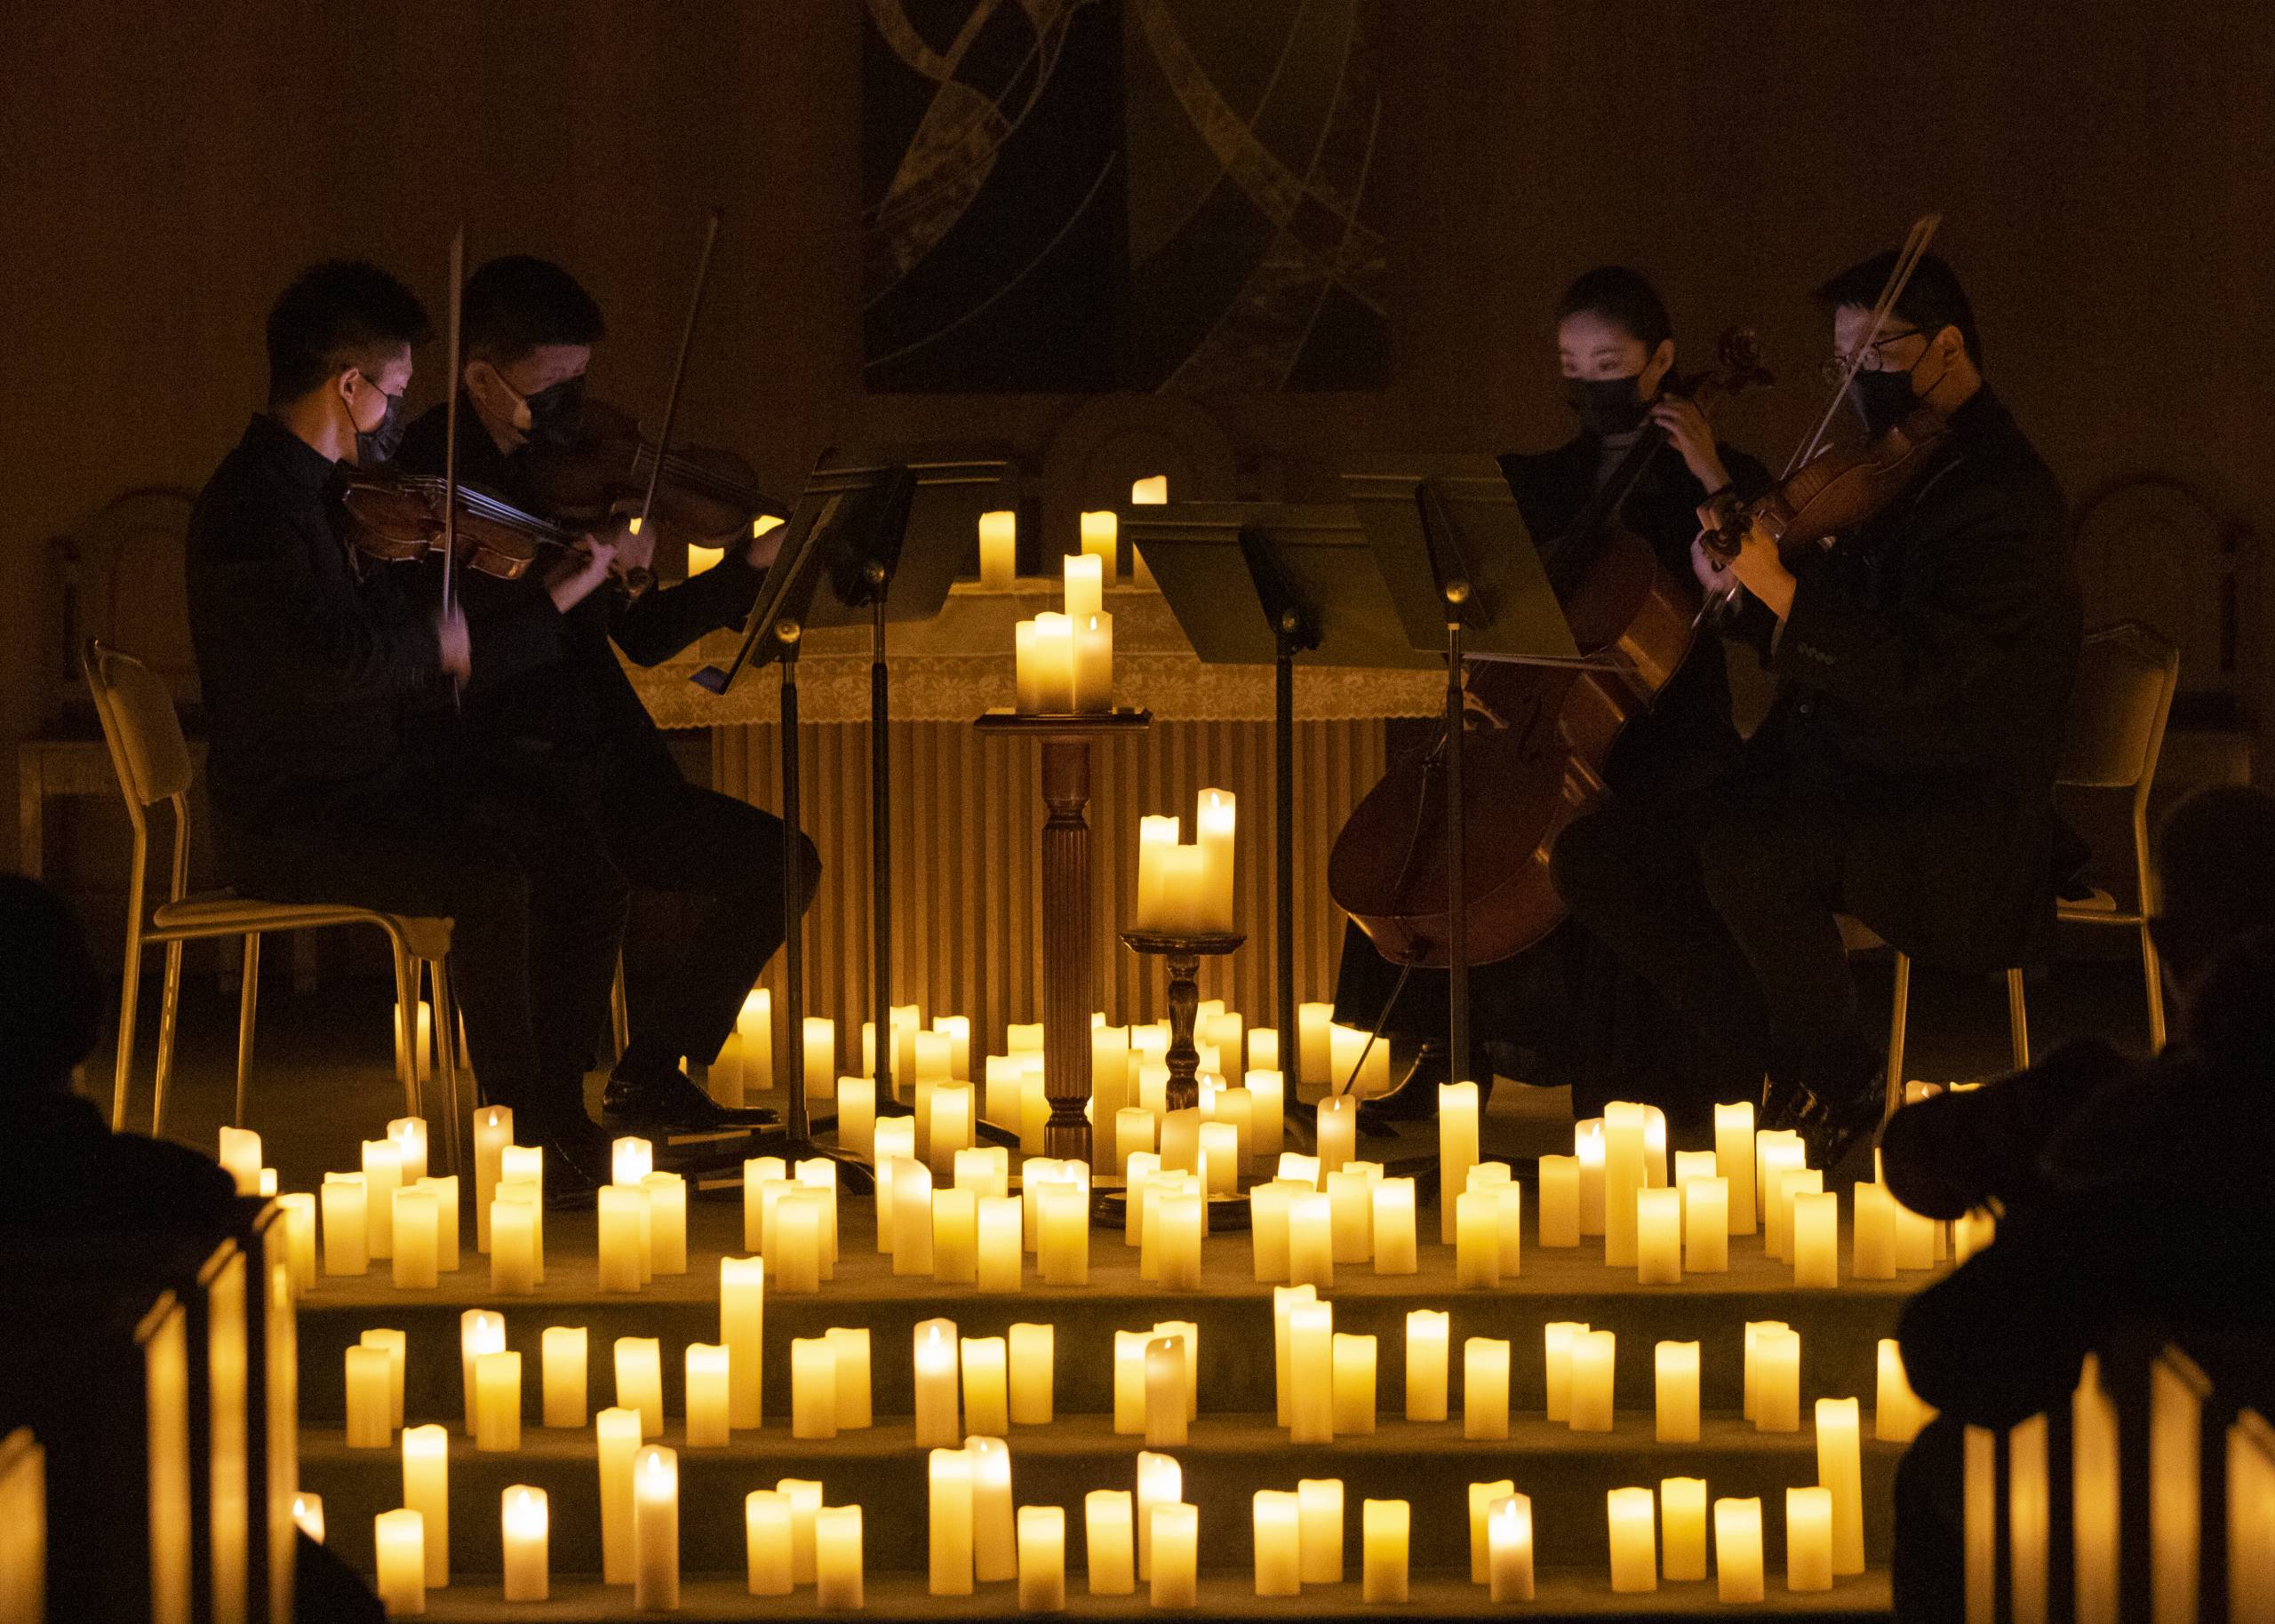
(1336, 267), (1768, 1126)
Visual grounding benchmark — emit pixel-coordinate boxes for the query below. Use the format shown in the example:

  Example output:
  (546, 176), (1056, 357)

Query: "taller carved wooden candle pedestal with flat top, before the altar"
(974, 710), (1155, 1162)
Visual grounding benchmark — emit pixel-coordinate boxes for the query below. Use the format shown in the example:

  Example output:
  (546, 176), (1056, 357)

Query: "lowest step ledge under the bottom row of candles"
(395, 1564), (1888, 1624)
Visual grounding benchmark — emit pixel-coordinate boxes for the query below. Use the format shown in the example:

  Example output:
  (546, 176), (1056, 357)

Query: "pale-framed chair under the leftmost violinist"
(86, 641), (459, 1155)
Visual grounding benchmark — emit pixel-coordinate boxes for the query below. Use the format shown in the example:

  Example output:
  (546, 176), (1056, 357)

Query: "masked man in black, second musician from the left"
(398, 255), (821, 1128)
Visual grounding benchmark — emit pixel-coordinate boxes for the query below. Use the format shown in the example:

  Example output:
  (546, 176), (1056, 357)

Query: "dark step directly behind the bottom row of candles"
(300, 1413), (1902, 1574)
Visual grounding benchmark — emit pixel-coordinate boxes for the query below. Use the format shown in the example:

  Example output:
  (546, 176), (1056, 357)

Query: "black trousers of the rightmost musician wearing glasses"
(1552, 762), (1877, 1087)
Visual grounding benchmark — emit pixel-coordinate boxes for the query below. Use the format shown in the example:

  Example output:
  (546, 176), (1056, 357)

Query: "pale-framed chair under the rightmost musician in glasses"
(1840, 621), (2179, 1115)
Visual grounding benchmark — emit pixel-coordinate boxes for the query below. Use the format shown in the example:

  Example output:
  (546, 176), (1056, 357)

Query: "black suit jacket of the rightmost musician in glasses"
(1743, 389), (2081, 969)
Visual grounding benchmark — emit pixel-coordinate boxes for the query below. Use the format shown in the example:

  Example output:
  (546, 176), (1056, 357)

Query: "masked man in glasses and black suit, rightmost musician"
(1553, 252), (2079, 1172)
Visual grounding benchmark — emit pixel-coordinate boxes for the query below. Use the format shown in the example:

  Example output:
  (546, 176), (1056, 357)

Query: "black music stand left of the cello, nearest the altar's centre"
(1122, 503), (1435, 1096)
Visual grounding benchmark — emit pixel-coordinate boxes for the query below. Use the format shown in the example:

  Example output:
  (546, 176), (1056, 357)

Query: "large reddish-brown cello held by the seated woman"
(1326, 330), (1770, 969)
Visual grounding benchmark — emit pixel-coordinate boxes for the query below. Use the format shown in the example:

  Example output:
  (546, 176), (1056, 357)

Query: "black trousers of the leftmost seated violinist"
(228, 773), (626, 1133)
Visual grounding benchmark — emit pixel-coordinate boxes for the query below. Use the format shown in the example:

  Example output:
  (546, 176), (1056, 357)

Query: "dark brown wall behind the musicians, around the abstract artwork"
(0, 0), (2275, 873)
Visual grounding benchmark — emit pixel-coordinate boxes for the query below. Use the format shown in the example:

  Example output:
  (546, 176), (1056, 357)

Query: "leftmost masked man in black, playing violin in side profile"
(188, 261), (623, 1198)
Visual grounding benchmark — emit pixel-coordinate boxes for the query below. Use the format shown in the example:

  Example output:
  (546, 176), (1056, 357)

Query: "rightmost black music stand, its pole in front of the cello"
(1342, 458), (1588, 1079)
